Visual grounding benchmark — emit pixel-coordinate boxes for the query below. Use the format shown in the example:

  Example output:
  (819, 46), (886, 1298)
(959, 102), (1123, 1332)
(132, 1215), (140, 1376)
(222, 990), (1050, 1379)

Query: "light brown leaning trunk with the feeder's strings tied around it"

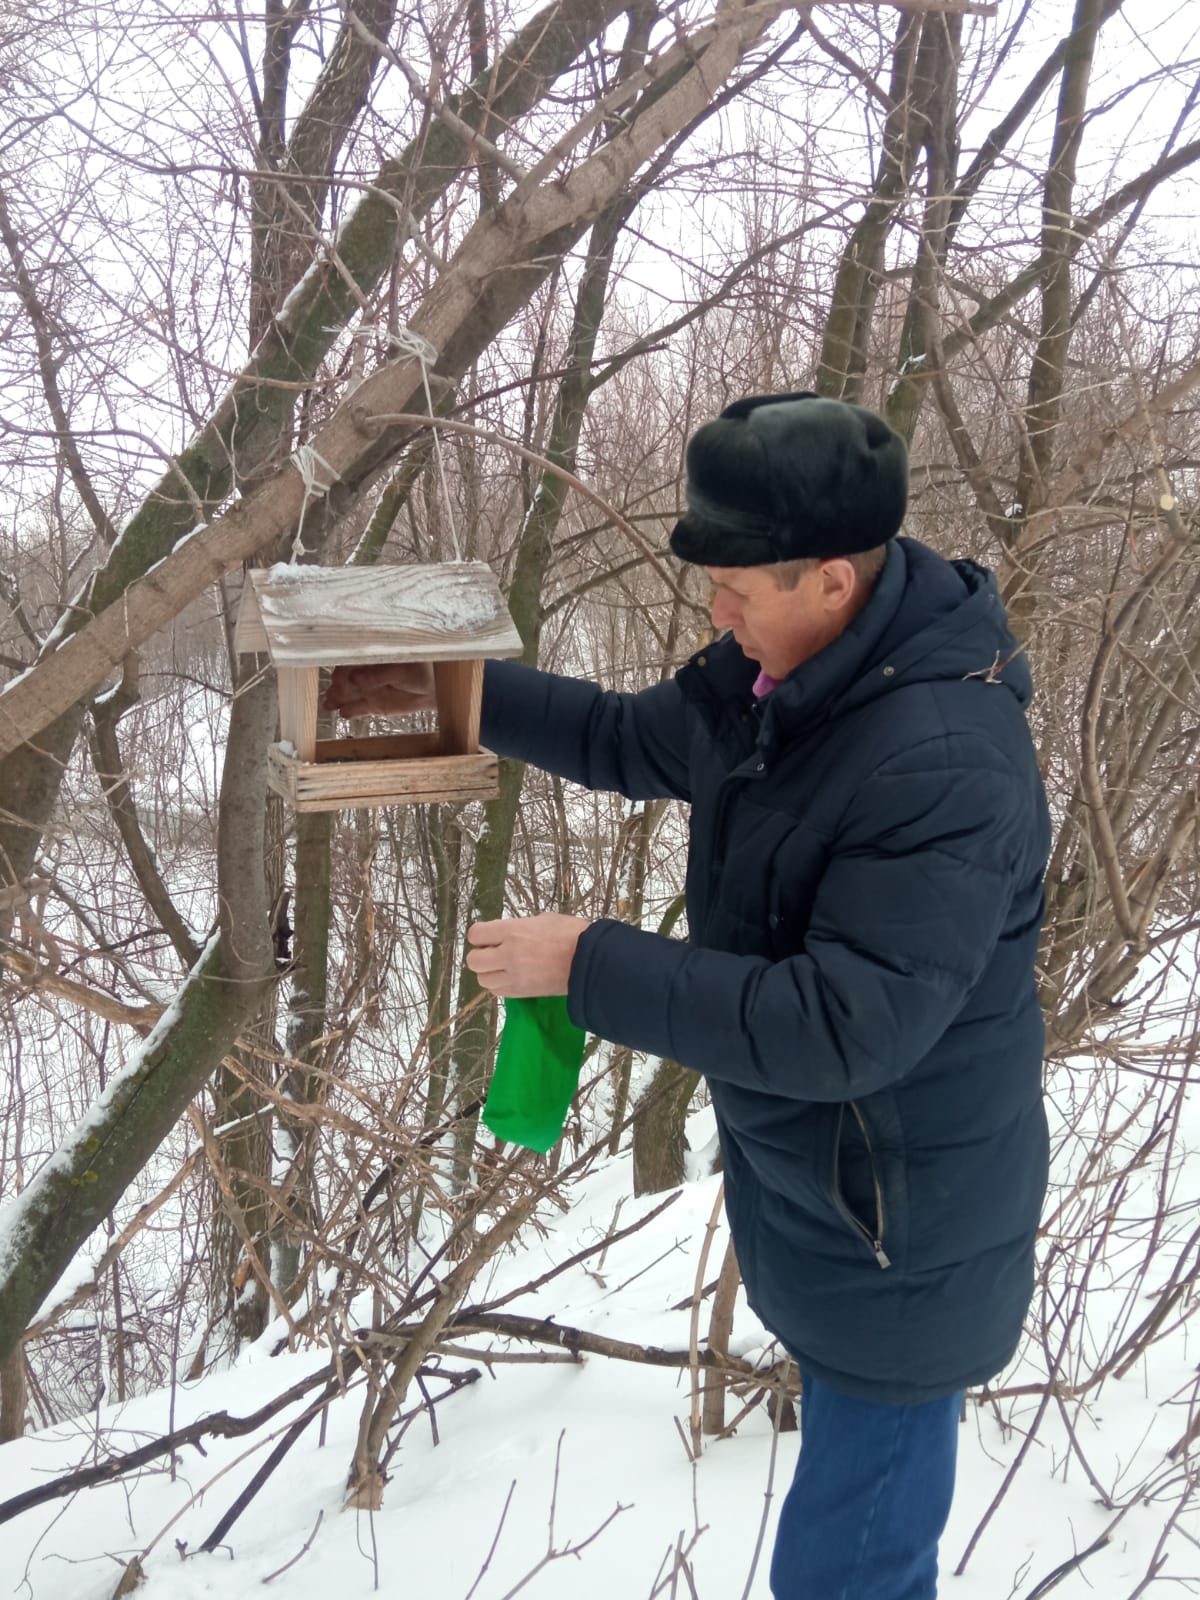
(0, 0), (784, 776)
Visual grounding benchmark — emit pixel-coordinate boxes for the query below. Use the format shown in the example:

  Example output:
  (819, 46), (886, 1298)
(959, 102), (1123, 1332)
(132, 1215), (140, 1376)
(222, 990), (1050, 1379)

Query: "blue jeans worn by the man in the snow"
(771, 1373), (963, 1600)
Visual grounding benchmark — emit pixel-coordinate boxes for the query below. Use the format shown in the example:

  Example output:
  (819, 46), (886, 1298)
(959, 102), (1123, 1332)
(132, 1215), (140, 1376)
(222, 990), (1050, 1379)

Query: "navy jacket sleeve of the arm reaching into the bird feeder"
(480, 661), (690, 800)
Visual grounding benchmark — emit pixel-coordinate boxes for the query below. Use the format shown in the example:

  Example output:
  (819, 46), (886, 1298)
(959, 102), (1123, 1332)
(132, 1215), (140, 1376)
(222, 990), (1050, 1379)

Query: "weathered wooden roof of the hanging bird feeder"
(235, 562), (523, 667)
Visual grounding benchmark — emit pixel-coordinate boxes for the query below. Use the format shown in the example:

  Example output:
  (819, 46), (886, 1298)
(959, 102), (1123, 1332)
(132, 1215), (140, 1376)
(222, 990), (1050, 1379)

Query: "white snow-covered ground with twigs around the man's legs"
(0, 1112), (1200, 1600)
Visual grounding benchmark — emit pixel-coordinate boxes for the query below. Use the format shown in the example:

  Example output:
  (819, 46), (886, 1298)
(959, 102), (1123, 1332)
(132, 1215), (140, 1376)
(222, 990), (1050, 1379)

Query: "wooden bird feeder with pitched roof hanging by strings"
(235, 562), (522, 811)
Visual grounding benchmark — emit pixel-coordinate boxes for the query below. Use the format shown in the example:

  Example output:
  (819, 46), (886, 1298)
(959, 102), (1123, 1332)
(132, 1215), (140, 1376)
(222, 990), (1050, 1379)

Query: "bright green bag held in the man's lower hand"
(483, 995), (584, 1155)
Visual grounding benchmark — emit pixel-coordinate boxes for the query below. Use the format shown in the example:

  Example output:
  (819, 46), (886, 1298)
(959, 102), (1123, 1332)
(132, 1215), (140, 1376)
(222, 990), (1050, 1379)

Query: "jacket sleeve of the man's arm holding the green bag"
(568, 739), (1037, 1101)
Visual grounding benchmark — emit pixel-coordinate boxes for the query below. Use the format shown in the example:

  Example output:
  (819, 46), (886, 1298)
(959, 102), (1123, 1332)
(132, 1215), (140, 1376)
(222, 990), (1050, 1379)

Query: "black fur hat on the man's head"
(670, 390), (909, 566)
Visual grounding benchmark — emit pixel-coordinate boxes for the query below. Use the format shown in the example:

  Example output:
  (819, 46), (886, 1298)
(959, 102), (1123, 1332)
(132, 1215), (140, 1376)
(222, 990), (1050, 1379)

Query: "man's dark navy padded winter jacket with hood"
(482, 539), (1050, 1402)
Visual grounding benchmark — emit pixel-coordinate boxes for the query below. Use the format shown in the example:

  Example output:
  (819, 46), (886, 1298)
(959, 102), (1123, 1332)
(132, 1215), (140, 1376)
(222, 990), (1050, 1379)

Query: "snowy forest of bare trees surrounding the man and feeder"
(0, 0), (1200, 1600)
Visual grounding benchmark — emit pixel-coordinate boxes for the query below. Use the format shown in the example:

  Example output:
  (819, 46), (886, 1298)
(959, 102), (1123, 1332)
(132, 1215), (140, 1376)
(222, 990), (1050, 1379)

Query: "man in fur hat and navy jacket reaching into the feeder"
(331, 394), (1050, 1600)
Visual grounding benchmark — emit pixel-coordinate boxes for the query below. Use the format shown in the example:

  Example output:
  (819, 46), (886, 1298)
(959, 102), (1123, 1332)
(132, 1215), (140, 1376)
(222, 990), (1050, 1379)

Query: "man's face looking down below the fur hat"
(704, 560), (854, 678)
